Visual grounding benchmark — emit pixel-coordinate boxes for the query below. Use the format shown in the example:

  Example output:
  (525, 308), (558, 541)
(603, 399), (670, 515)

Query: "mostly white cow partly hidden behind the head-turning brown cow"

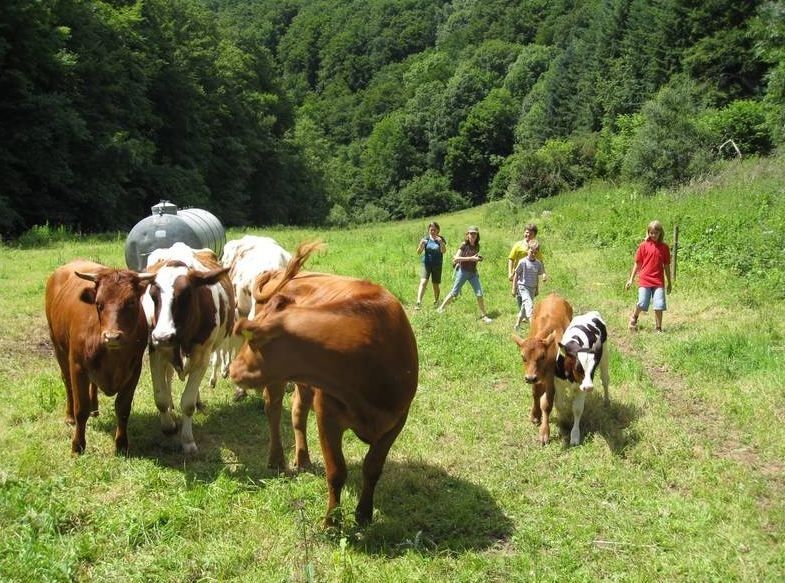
(210, 235), (292, 401)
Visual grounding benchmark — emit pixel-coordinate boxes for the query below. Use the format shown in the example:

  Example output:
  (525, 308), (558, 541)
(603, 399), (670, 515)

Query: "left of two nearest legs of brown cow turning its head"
(314, 391), (346, 528)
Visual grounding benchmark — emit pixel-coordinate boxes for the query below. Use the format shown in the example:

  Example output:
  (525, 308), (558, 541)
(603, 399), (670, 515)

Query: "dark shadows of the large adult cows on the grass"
(90, 396), (513, 556)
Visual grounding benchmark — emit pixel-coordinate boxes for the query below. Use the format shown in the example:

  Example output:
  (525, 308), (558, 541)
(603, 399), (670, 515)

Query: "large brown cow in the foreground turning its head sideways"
(230, 244), (419, 526)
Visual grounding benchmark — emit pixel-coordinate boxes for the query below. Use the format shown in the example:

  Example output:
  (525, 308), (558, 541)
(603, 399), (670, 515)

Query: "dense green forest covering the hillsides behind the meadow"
(0, 0), (785, 240)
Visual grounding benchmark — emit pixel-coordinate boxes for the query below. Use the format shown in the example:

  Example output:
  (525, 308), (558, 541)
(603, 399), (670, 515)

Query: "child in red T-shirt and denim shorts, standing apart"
(624, 221), (671, 332)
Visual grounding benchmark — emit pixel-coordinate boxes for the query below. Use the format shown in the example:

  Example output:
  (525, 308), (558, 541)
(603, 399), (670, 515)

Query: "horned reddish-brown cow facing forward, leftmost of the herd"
(46, 260), (153, 453)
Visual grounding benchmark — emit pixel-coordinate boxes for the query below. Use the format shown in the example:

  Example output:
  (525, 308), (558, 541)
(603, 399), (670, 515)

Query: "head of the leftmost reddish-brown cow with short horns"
(74, 269), (155, 349)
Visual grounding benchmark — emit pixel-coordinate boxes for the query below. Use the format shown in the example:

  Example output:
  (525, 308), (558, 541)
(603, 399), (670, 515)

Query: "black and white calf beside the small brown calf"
(555, 312), (609, 445)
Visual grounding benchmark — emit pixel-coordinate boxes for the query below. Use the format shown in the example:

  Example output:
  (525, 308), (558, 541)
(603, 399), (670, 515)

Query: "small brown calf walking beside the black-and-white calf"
(513, 294), (572, 445)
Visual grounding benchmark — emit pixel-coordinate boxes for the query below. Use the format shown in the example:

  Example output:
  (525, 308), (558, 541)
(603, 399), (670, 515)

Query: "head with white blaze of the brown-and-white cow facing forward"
(148, 261), (229, 346)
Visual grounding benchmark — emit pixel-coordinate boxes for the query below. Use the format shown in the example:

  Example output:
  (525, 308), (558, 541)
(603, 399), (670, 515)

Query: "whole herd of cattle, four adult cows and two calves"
(41, 236), (608, 524)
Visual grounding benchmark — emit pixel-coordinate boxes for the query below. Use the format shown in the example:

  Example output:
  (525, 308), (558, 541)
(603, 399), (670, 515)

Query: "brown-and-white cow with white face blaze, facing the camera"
(142, 243), (234, 454)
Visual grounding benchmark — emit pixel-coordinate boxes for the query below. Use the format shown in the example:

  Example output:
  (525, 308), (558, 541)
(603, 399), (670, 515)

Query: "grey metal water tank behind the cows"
(125, 200), (226, 271)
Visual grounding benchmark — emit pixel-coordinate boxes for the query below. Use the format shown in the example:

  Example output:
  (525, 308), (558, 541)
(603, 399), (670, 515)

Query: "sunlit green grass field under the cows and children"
(0, 157), (785, 583)
